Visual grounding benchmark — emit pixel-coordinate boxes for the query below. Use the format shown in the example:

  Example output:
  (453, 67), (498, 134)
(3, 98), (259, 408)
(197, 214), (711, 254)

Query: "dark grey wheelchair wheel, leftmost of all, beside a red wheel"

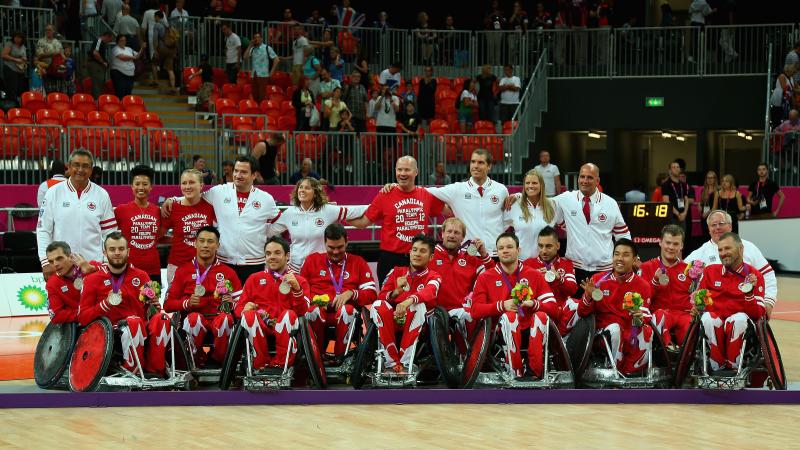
(33, 322), (78, 389)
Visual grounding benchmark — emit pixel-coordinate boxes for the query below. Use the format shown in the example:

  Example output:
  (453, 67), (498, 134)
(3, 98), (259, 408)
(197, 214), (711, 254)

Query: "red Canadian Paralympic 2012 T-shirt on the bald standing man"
(364, 187), (444, 254)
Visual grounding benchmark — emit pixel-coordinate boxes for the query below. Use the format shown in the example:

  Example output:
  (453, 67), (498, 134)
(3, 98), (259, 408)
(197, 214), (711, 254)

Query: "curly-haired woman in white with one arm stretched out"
(267, 177), (367, 272)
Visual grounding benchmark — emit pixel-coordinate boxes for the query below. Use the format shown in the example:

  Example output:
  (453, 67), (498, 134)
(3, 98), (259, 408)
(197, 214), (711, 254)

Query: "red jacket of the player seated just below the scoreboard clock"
(641, 256), (692, 312)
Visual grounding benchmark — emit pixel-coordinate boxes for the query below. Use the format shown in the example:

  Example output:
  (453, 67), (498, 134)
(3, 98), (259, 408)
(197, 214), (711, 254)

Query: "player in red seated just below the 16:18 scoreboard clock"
(640, 225), (692, 349)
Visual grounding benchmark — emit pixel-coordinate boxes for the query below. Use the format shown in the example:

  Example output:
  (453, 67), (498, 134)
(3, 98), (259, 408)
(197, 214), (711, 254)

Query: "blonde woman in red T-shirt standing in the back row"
(163, 169), (217, 284)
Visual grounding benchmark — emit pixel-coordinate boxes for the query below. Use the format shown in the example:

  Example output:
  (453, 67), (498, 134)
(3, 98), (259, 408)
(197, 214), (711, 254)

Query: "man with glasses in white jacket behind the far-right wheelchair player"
(685, 209), (778, 317)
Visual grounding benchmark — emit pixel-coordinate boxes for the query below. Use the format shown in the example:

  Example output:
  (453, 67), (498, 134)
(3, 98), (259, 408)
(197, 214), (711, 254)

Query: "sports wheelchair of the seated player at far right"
(675, 316), (786, 390)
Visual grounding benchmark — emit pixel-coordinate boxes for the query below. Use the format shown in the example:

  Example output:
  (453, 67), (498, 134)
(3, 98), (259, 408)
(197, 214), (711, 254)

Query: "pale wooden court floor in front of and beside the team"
(0, 276), (800, 448)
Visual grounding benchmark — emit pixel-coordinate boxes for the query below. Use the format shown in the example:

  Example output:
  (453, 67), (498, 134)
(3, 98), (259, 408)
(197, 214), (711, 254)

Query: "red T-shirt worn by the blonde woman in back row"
(163, 200), (216, 267)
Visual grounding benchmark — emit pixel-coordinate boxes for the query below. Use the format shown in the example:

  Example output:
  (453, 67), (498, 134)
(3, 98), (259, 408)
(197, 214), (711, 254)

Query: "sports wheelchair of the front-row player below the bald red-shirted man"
(349, 307), (459, 389)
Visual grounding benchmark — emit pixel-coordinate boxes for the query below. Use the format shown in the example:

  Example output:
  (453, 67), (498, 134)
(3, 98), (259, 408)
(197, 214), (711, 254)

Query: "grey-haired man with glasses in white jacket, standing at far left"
(36, 150), (117, 280)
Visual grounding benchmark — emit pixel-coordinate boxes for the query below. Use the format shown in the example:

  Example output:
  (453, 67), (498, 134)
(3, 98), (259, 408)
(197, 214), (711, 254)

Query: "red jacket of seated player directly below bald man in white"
(578, 272), (651, 330)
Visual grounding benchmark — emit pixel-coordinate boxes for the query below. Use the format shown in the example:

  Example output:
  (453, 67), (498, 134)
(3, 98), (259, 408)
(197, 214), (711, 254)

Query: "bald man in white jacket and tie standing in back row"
(555, 163), (631, 298)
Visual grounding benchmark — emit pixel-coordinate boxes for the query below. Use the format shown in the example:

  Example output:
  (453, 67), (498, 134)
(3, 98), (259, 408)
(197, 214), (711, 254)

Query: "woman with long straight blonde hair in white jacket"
(503, 170), (556, 260)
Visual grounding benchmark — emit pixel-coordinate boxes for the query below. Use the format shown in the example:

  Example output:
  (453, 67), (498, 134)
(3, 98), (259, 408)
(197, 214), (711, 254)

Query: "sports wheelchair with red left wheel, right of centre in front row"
(461, 318), (575, 389)
